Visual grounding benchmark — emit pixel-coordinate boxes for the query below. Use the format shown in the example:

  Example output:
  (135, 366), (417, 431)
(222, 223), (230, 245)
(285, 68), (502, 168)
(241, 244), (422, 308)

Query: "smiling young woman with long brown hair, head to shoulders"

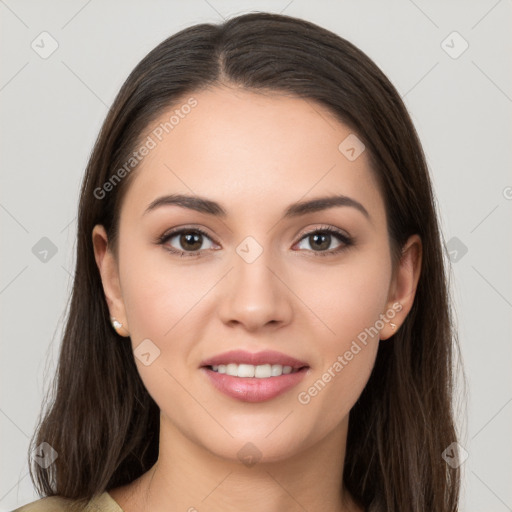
(19, 13), (460, 512)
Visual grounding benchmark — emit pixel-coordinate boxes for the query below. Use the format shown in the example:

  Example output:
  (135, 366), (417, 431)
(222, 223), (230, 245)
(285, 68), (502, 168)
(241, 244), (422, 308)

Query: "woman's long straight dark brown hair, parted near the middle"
(31, 13), (466, 512)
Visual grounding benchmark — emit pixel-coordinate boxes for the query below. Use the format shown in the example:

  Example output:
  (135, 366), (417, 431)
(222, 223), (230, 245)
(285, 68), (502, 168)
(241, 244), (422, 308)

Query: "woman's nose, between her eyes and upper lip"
(218, 251), (293, 332)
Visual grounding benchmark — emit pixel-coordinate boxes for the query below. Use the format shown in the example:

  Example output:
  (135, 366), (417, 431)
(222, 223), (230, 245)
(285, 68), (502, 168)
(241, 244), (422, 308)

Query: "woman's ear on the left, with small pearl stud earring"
(92, 224), (130, 336)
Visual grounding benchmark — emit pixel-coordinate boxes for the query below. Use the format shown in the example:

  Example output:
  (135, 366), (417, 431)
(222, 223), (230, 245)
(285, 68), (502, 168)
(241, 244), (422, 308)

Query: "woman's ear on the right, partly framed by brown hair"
(380, 235), (422, 340)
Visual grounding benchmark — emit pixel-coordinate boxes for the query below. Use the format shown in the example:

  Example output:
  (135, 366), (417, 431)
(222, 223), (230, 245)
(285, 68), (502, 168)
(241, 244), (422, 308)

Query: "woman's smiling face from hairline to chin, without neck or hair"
(96, 88), (414, 461)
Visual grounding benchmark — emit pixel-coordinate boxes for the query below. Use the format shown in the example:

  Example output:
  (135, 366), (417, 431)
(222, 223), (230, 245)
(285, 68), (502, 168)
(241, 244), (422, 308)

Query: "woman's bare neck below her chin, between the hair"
(119, 415), (360, 512)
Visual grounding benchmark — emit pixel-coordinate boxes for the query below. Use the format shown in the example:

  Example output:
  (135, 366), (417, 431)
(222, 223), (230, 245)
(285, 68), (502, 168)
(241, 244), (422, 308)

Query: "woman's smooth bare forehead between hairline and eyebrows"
(120, 87), (384, 224)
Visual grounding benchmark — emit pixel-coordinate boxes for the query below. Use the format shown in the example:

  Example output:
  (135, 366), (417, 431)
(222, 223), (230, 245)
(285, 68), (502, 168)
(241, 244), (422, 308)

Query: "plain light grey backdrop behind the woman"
(0, 0), (512, 512)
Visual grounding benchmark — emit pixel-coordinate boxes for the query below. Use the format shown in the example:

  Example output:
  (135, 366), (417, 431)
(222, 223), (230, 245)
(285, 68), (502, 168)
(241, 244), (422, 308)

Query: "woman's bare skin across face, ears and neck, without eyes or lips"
(92, 87), (421, 512)
